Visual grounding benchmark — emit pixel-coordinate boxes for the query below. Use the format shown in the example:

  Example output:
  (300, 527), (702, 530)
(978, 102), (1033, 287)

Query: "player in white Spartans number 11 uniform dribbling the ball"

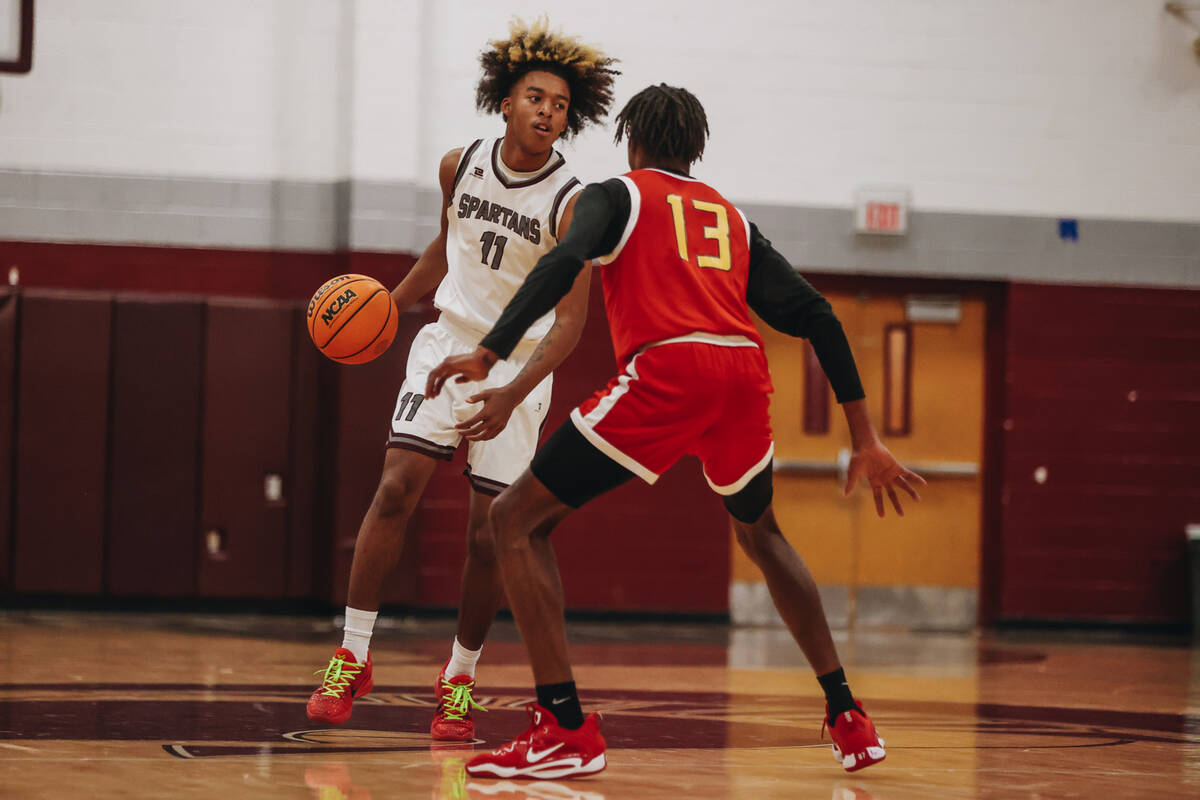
(307, 19), (617, 740)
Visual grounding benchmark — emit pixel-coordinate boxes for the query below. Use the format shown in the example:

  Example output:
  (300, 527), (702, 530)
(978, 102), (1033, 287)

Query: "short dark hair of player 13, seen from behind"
(613, 83), (708, 164)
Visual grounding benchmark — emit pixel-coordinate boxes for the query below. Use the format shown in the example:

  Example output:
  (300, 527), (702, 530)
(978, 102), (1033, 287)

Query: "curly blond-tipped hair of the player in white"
(475, 17), (620, 138)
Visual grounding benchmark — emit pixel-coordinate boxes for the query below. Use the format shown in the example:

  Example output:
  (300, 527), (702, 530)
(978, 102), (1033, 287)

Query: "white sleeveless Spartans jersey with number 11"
(433, 139), (582, 341)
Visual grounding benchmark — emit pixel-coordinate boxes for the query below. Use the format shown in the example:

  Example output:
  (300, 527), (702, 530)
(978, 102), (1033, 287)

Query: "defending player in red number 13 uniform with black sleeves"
(426, 84), (924, 778)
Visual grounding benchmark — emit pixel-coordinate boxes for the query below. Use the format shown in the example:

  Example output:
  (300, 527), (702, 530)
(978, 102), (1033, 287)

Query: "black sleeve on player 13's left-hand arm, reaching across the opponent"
(480, 179), (630, 359)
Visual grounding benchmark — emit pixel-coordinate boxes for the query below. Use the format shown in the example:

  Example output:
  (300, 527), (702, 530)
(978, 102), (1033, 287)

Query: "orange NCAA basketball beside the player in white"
(308, 275), (397, 363)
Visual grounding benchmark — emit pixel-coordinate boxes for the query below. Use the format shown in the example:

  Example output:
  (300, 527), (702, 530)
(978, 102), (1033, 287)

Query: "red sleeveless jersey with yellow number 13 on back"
(596, 169), (762, 367)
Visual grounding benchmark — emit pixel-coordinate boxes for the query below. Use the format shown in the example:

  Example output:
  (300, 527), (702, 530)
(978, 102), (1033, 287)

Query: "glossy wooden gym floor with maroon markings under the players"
(0, 612), (1200, 800)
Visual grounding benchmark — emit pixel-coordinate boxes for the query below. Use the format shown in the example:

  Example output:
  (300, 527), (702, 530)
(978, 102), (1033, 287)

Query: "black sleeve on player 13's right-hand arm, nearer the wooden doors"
(746, 223), (866, 403)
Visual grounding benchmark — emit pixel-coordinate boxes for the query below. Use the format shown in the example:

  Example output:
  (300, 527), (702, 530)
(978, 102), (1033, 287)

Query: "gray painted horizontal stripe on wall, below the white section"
(0, 170), (1200, 288)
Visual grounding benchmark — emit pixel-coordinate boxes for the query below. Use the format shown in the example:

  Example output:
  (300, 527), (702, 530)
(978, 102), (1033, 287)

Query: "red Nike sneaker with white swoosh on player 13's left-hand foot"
(467, 703), (606, 778)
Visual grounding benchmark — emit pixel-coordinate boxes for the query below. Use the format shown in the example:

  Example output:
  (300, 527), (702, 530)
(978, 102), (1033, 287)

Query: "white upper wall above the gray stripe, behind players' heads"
(0, 0), (1200, 221)
